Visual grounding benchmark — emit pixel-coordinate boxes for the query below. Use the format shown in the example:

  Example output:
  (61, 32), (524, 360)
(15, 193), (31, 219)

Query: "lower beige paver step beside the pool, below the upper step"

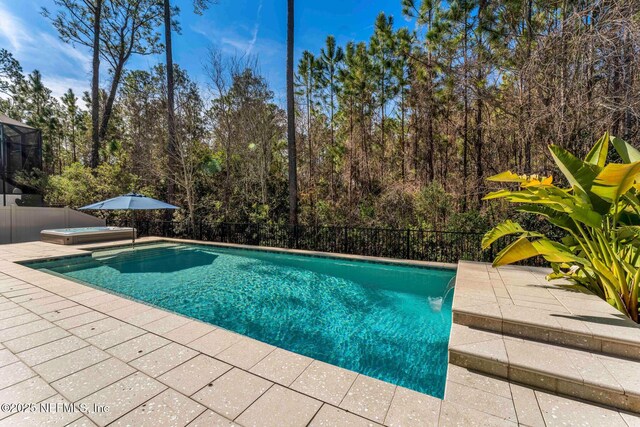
(449, 324), (640, 412)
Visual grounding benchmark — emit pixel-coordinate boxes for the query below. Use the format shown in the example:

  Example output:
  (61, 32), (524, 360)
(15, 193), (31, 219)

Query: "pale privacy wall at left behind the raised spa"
(0, 205), (106, 244)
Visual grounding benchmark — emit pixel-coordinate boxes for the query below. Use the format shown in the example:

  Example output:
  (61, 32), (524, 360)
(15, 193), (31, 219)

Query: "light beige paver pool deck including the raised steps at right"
(0, 238), (640, 426)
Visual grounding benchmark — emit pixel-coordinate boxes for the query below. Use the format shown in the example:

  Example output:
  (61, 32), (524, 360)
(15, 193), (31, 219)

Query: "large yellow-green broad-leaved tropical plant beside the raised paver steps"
(482, 133), (640, 322)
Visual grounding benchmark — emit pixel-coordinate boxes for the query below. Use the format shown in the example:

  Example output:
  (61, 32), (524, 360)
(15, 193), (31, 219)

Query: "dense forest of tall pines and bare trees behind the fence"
(0, 0), (640, 231)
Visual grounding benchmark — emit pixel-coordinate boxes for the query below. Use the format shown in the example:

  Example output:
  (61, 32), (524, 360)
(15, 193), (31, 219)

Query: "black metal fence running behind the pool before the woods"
(120, 221), (497, 263)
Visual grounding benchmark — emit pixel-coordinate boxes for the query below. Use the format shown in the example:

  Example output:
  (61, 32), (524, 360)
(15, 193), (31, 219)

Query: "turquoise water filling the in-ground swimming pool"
(28, 245), (455, 397)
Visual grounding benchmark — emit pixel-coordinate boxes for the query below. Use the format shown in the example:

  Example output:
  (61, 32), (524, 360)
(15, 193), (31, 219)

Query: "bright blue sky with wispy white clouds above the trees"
(0, 0), (404, 104)
